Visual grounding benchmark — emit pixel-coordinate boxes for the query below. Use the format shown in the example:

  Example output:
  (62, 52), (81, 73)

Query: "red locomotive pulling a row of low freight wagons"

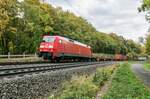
(38, 35), (124, 62)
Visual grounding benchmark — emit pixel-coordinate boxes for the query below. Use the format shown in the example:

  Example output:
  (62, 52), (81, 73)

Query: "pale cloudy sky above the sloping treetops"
(45, 0), (149, 41)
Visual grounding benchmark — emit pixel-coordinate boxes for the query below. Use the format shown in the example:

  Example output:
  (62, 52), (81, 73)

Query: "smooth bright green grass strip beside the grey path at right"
(103, 63), (150, 99)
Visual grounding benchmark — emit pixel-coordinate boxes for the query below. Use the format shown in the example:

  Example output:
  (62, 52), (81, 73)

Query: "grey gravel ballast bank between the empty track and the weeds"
(0, 63), (111, 99)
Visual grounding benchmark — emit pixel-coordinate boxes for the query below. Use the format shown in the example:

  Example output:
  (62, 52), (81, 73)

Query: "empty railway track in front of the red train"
(0, 61), (114, 78)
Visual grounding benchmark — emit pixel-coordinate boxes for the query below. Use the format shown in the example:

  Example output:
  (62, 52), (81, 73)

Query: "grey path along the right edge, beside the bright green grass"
(132, 64), (150, 88)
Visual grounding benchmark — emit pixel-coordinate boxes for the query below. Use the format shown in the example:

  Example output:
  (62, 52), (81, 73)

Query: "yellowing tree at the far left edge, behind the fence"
(0, 0), (18, 53)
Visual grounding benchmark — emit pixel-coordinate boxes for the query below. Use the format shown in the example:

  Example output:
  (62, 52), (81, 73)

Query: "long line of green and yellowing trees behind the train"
(0, 0), (141, 55)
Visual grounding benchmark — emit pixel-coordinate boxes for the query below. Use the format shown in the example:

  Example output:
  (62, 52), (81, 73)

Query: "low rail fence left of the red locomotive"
(0, 53), (37, 59)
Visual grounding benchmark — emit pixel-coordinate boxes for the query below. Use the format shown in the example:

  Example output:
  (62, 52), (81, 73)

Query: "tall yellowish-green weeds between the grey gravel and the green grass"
(49, 65), (116, 99)
